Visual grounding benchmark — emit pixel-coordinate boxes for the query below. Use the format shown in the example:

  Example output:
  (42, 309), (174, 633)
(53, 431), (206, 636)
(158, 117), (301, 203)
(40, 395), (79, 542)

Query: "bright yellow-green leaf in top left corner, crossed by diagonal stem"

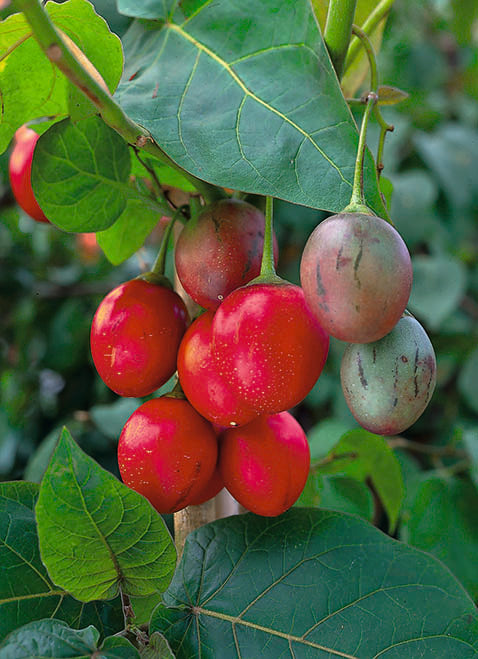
(0, 0), (123, 153)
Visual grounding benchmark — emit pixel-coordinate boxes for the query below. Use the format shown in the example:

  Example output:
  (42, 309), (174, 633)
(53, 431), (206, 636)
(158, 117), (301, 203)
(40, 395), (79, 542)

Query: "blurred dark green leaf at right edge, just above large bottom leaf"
(400, 475), (478, 600)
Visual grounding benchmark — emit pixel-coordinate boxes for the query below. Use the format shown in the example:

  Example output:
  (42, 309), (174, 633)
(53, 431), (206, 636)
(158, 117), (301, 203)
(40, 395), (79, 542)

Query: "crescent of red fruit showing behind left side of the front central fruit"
(178, 311), (257, 427)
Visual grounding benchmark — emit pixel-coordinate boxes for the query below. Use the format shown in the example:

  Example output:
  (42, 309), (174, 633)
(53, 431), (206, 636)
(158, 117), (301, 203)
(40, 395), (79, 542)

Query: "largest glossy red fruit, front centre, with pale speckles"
(212, 282), (329, 414)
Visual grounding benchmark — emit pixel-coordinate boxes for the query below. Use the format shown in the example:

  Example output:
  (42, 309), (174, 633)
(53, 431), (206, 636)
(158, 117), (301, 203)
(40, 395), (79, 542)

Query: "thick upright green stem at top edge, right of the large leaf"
(324, 0), (357, 80)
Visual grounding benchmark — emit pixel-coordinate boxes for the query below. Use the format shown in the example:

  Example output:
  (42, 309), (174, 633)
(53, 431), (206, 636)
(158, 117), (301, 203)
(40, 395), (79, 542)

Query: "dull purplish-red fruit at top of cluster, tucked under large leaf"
(175, 199), (278, 310)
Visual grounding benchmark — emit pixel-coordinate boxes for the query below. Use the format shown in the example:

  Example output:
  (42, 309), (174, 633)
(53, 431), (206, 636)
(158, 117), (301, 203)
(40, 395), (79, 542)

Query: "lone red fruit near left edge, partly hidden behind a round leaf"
(8, 126), (48, 222)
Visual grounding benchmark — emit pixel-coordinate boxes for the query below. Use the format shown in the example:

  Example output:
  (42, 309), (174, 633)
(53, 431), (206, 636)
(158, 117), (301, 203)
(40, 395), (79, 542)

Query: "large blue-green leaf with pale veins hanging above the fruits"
(116, 0), (384, 214)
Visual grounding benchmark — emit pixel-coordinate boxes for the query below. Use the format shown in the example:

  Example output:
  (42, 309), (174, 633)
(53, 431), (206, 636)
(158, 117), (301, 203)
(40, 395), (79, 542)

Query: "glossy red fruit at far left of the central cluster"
(90, 279), (188, 396)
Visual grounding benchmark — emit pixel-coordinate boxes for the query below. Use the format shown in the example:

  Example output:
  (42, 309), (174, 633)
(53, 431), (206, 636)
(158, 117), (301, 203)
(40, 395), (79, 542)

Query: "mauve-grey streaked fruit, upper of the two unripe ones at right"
(300, 213), (413, 343)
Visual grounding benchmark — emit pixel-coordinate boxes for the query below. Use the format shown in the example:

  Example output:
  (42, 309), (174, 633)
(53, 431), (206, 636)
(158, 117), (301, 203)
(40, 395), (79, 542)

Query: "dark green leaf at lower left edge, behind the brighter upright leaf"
(0, 481), (123, 639)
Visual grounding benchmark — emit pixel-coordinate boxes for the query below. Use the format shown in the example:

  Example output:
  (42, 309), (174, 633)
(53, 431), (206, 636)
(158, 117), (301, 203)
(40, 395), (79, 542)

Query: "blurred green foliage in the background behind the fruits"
(0, 0), (478, 600)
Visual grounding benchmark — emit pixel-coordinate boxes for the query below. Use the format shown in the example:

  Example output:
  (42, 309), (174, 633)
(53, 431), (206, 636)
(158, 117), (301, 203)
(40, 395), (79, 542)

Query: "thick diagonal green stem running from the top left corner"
(16, 0), (225, 202)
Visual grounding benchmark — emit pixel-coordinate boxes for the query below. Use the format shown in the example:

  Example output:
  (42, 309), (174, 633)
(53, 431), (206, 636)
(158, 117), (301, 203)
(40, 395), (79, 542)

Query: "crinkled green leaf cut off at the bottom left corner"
(0, 620), (100, 659)
